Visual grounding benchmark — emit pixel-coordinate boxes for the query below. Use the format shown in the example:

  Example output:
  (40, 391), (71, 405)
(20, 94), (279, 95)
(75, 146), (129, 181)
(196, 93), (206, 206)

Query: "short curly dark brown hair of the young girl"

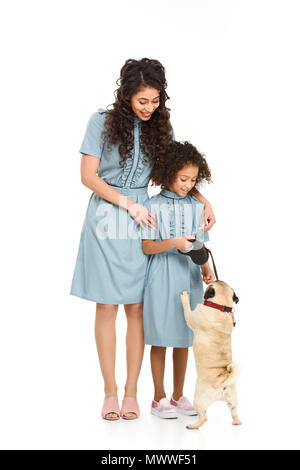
(150, 140), (212, 196)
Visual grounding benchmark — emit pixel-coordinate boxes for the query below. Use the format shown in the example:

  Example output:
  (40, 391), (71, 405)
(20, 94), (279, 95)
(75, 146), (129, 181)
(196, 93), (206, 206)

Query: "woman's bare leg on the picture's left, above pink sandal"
(95, 303), (118, 418)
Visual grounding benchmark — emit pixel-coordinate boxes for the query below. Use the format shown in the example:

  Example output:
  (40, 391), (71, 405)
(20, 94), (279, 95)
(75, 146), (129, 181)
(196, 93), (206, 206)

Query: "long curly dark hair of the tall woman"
(103, 58), (172, 167)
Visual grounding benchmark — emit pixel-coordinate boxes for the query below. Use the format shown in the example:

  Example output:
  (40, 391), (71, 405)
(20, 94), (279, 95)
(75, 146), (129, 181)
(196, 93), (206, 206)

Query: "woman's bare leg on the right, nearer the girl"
(124, 302), (145, 417)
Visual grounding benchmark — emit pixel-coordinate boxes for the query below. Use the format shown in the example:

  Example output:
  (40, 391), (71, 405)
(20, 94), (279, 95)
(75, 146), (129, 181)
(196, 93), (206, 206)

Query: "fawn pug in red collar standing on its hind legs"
(179, 281), (242, 429)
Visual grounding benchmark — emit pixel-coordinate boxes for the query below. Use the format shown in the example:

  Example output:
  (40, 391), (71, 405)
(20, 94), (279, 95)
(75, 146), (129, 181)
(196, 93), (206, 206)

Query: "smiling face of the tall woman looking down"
(130, 87), (159, 121)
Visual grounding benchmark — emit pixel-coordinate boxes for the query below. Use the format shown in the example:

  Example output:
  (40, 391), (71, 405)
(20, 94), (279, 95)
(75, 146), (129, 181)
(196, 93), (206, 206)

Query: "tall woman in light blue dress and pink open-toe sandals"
(70, 58), (215, 420)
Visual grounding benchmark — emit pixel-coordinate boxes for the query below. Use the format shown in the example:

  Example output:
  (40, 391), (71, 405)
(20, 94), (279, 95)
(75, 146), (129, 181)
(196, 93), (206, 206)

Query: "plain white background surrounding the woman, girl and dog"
(0, 0), (300, 449)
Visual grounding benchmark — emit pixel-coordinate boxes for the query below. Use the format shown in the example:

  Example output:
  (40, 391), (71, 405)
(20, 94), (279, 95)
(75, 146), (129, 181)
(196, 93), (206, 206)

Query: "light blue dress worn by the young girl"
(142, 189), (209, 348)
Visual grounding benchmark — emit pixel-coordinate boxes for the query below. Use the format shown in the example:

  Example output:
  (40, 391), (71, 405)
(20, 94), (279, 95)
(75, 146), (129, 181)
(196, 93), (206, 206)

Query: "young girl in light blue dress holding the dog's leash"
(142, 141), (214, 418)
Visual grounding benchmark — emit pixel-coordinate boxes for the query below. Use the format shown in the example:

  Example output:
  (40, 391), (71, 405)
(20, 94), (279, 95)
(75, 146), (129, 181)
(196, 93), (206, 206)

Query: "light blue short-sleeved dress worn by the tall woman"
(70, 108), (153, 305)
